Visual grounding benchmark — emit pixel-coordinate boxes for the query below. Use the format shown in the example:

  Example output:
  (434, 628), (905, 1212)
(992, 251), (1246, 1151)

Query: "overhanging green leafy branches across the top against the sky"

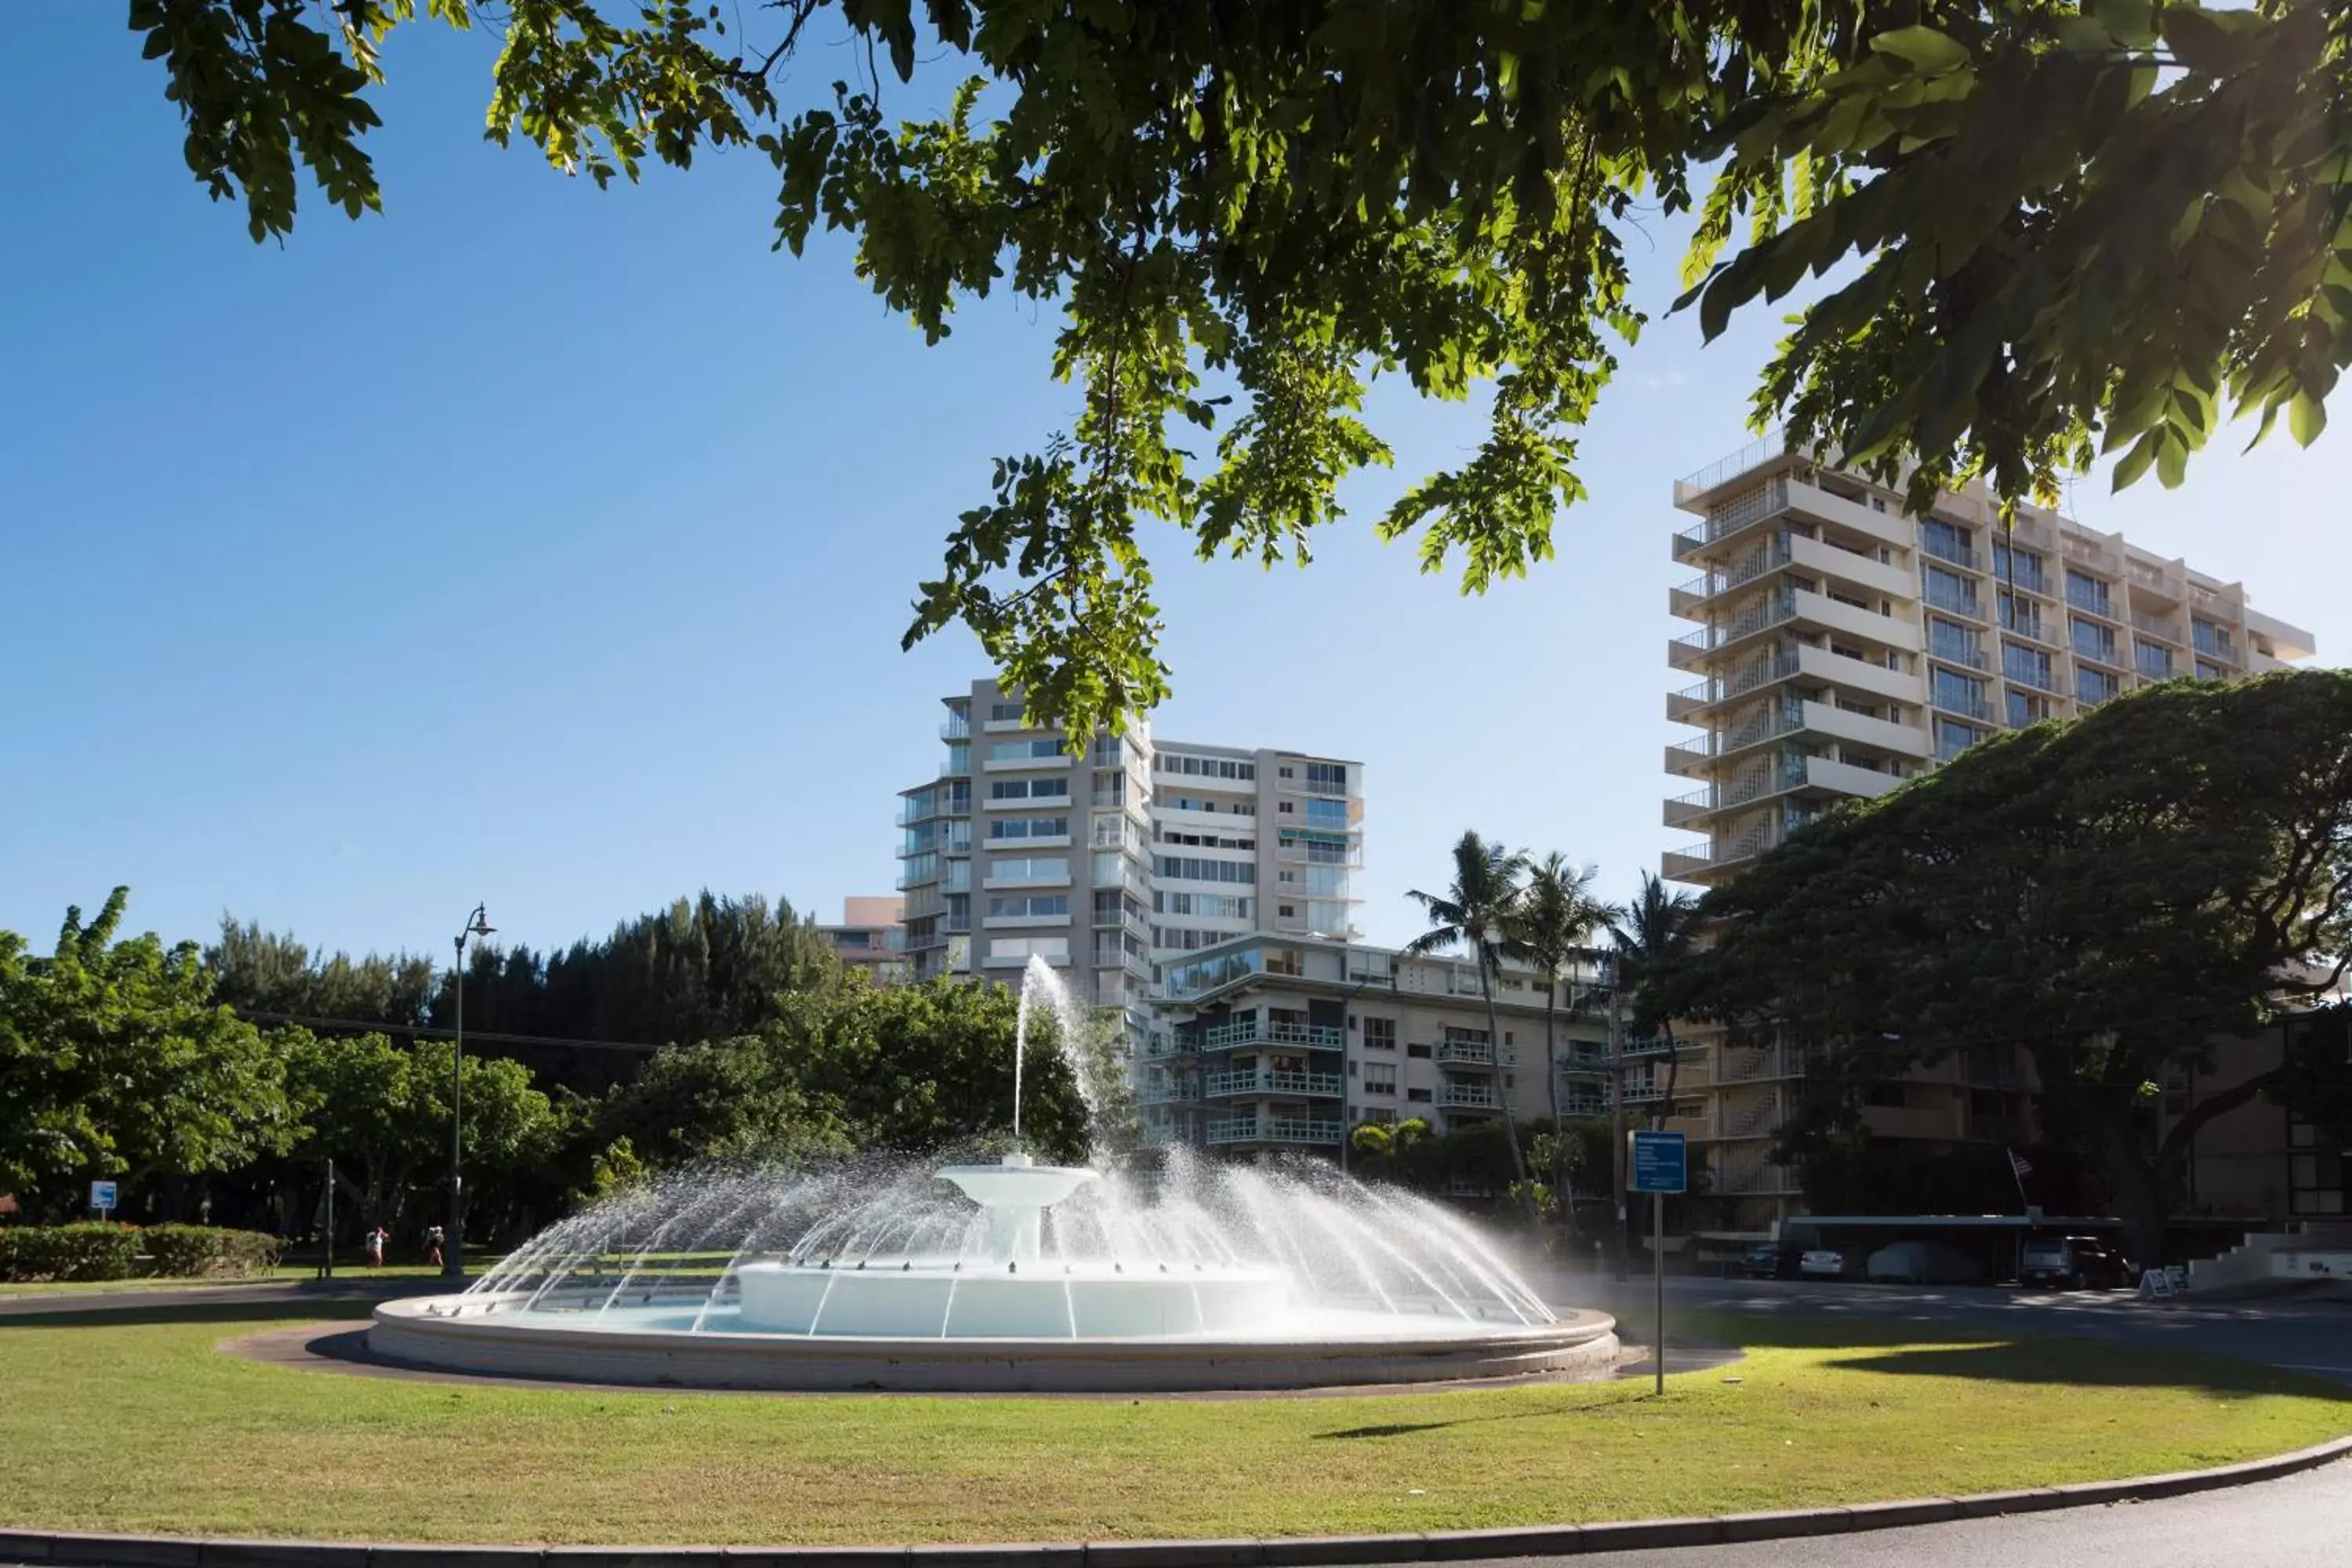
(114, 0), (2352, 736)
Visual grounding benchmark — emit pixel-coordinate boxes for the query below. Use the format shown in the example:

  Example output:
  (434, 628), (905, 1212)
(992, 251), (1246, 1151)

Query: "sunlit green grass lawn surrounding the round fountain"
(0, 1302), (2352, 1542)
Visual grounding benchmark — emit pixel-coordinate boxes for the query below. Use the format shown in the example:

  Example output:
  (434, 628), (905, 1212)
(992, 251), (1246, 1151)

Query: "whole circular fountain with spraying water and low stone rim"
(369, 966), (1616, 1392)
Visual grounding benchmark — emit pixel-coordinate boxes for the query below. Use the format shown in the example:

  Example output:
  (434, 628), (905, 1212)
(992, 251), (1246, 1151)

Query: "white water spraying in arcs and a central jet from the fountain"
(468, 961), (1552, 1340)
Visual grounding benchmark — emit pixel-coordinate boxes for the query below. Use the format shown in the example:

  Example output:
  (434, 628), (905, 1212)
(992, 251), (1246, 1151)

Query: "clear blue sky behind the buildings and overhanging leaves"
(0, 0), (2352, 956)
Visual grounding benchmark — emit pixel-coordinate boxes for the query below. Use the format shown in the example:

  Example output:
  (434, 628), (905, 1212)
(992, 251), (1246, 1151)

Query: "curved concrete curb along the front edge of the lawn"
(0, 1436), (2352, 1568)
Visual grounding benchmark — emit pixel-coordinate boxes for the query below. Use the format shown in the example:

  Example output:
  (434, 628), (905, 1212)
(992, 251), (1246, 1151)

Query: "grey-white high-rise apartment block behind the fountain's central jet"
(898, 682), (1364, 1036)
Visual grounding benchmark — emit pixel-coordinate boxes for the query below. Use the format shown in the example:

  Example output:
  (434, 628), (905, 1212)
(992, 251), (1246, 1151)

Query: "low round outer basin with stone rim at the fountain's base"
(367, 1293), (1618, 1394)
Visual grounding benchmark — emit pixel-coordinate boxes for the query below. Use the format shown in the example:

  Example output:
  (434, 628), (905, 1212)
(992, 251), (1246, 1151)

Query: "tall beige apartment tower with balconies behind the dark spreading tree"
(1661, 440), (2314, 1229)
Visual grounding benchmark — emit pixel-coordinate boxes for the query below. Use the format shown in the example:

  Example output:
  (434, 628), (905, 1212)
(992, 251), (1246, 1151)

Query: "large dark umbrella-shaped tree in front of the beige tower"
(1675, 670), (2352, 1258)
